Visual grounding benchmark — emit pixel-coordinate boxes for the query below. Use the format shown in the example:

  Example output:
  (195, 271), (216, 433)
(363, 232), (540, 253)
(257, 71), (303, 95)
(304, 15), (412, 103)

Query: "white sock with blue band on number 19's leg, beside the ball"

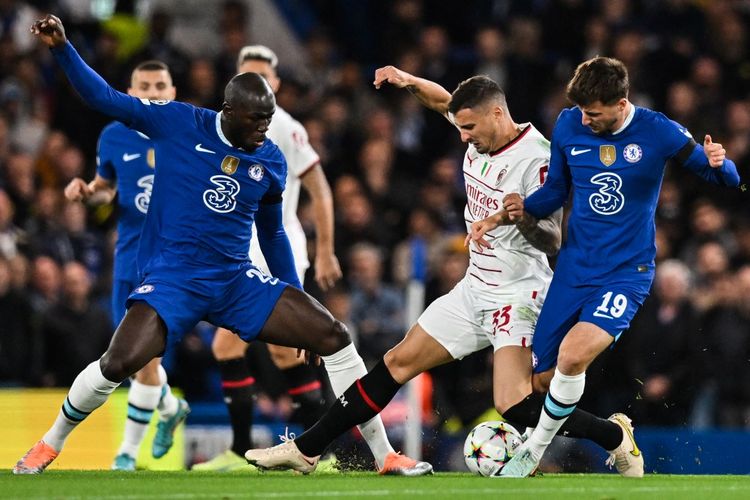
(528, 369), (586, 459)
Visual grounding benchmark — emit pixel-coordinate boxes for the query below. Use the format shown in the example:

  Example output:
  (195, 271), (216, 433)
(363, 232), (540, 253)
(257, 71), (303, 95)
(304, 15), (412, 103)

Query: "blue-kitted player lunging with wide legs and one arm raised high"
(13, 15), (432, 474)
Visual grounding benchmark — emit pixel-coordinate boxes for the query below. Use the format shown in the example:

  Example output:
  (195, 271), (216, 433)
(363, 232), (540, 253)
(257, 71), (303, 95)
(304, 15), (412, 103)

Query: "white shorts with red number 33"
(417, 277), (547, 359)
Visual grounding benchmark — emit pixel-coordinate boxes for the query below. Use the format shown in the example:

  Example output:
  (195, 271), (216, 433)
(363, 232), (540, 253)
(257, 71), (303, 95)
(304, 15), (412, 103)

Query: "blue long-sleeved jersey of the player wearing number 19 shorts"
(525, 106), (736, 285)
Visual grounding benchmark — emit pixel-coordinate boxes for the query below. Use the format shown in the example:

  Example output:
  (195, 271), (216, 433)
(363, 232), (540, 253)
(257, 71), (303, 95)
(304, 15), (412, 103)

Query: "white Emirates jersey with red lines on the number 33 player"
(463, 123), (552, 295)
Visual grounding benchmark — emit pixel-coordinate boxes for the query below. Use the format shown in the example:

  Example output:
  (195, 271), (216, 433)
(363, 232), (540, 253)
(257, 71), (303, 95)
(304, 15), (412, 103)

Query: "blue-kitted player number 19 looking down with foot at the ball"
(471, 57), (739, 477)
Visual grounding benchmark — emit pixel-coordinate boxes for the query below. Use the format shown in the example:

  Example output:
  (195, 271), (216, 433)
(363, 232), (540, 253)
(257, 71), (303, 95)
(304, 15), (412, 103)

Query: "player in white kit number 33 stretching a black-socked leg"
(245, 66), (636, 476)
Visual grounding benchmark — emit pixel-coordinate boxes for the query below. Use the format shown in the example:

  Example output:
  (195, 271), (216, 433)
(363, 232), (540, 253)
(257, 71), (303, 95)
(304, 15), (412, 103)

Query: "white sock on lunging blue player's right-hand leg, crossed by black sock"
(322, 344), (394, 468)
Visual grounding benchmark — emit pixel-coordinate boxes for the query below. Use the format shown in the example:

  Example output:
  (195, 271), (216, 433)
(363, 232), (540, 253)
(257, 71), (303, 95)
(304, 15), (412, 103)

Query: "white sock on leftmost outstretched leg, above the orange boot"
(42, 359), (120, 452)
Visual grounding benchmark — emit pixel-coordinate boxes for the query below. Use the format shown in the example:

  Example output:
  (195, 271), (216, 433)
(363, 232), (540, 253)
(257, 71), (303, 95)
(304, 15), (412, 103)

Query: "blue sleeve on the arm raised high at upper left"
(51, 42), (177, 138)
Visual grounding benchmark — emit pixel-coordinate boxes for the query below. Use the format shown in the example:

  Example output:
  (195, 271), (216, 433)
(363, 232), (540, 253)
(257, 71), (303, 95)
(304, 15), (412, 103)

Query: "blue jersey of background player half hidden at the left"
(96, 122), (155, 282)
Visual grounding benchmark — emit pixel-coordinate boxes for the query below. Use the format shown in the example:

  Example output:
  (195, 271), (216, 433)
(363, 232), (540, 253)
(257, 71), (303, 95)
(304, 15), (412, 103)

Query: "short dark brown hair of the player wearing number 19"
(566, 57), (630, 106)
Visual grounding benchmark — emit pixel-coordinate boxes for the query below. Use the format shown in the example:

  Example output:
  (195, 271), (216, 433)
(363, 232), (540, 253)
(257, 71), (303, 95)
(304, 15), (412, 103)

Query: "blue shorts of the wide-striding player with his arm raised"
(127, 262), (288, 347)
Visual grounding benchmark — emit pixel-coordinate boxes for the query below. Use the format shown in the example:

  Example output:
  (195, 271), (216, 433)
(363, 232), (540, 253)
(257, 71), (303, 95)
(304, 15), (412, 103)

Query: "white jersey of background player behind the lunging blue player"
(250, 106), (320, 282)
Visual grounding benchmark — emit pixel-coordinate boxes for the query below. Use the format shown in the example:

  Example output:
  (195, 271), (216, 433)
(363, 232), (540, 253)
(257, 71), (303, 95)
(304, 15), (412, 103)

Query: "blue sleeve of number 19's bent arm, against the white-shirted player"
(524, 115), (571, 219)
